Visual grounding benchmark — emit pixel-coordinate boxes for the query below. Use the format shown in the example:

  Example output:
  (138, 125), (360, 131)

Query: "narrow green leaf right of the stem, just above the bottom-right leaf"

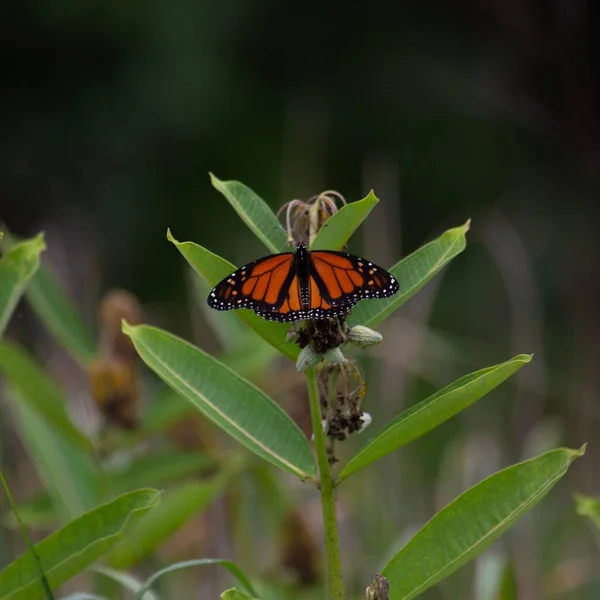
(338, 354), (531, 484)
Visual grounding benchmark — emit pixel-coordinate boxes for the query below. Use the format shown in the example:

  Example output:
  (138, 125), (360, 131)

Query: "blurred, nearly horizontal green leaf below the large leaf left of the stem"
(110, 450), (216, 493)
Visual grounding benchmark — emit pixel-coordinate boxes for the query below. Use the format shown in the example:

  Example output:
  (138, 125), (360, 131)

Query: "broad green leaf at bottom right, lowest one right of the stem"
(382, 448), (585, 600)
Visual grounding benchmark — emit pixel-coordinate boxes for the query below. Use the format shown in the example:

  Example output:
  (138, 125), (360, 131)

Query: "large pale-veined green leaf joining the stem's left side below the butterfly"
(123, 323), (315, 479)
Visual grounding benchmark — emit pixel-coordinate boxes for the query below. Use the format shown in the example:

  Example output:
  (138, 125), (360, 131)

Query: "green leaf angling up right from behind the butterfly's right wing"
(348, 220), (471, 327)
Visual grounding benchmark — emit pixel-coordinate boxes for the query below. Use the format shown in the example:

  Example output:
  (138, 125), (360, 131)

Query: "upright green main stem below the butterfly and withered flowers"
(306, 369), (344, 600)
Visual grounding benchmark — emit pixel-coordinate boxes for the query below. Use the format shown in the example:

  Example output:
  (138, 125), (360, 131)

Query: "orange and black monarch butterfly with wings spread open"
(208, 244), (398, 323)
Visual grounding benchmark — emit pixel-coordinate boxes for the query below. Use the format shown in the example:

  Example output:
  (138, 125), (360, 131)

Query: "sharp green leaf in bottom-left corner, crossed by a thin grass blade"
(0, 490), (160, 600)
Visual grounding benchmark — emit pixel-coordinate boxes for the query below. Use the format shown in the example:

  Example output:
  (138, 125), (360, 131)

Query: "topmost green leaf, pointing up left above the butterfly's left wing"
(210, 173), (287, 254)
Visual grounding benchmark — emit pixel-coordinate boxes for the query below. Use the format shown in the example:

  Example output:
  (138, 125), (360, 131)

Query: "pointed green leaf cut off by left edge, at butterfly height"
(0, 233), (46, 336)
